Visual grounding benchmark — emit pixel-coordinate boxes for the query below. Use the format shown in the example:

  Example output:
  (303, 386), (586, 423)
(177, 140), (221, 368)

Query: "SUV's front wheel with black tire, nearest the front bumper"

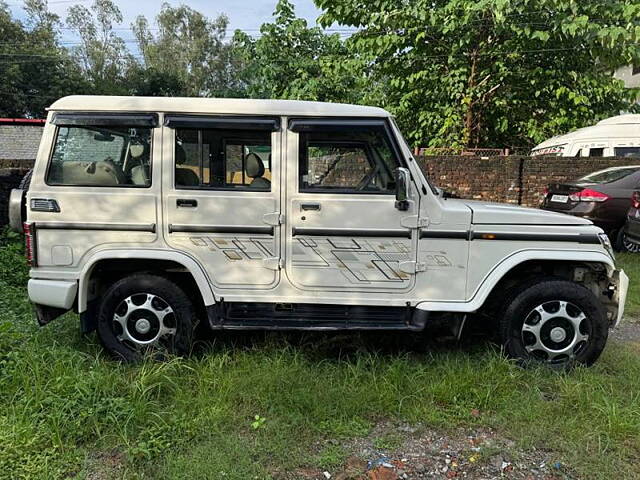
(499, 278), (609, 369)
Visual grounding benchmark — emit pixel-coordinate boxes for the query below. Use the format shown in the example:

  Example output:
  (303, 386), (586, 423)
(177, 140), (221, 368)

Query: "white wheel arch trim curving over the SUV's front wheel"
(416, 250), (615, 313)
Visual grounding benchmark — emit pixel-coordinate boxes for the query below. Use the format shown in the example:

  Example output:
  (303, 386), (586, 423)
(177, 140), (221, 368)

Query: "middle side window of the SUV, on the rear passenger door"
(175, 128), (271, 191)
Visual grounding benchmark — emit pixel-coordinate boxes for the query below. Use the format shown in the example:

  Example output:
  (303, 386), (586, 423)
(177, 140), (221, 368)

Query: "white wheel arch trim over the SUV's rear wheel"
(78, 250), (215, 313)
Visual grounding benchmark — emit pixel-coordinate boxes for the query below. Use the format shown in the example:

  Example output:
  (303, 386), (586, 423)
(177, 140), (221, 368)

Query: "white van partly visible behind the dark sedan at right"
(531, 114), (640, 157)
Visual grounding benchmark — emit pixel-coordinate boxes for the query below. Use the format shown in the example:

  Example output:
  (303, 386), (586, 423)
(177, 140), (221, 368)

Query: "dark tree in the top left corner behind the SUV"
(0, 0), (87, 117)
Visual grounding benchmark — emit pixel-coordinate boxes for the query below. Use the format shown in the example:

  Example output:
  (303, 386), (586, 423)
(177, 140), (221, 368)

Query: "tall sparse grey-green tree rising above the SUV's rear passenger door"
(133, 3), (235, 96)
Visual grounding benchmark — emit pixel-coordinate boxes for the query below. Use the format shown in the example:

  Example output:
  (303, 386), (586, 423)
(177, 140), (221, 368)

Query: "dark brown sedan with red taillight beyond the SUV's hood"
(542, 165), (640, 250)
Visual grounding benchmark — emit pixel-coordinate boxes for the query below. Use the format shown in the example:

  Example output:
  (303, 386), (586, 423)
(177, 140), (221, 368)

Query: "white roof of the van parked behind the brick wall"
(533, 113), (640, 150)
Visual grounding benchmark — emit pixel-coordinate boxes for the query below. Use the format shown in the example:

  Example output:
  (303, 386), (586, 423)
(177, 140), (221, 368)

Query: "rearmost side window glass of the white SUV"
(47, 126), (151, 187)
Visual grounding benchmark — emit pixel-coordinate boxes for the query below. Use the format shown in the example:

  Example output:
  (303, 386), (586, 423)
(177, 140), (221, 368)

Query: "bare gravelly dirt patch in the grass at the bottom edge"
(277, 422), (577, 480)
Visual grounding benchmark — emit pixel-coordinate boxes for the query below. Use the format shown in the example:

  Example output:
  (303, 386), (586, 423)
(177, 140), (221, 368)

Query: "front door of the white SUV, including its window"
(285, 118), (418, 292)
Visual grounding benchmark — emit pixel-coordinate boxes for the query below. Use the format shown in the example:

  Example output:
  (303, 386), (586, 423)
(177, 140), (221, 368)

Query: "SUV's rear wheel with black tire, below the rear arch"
(97, 274), (195, 362)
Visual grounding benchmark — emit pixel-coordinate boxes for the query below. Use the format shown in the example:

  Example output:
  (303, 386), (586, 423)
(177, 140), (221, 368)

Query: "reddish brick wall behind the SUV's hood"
(418, 156), (640, 207)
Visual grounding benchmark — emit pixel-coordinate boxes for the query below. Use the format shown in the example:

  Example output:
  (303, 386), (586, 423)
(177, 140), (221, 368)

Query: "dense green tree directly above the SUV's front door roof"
(234, 0), (365, 103)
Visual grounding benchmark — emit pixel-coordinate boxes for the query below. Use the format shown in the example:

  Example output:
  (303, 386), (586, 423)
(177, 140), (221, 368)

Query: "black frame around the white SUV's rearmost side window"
(44, 121), (158, 189)
